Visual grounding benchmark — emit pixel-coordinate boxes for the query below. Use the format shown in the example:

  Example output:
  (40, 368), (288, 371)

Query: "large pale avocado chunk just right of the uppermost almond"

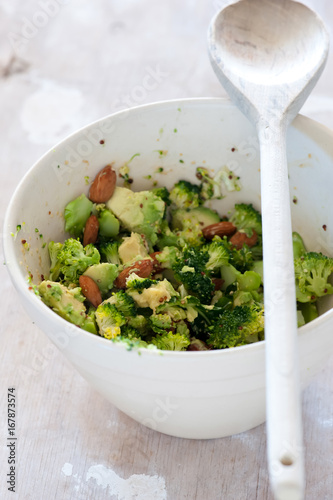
(106, 186), (165, 245)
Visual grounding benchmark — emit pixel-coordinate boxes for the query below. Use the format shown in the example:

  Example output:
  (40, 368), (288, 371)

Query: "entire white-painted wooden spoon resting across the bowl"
(208, 0), (329, 500)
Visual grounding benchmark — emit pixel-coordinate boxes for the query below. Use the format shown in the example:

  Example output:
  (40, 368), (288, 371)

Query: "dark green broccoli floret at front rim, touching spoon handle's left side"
(207, 304), (264, 349)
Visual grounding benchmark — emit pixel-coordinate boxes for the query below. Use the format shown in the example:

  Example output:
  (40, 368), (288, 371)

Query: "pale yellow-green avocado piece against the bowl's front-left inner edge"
(38, 280), (96, 333)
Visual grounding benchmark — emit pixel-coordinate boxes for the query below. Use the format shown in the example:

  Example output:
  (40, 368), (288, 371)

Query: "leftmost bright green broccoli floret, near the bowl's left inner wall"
(49, 238), (100, 284)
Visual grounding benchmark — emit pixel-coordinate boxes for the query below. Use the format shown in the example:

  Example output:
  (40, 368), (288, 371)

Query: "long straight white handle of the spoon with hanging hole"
(258, 120), (304, 500)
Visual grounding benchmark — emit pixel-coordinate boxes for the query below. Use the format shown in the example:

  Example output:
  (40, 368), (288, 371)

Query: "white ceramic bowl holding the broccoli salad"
(4, 99), (333, 439)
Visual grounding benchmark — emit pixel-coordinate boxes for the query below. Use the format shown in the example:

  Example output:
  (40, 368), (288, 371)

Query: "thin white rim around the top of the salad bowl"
(3, 97), (333, 360)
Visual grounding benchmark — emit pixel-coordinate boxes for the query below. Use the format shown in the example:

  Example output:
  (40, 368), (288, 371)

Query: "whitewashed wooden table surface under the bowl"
(0, 0), (333, 500)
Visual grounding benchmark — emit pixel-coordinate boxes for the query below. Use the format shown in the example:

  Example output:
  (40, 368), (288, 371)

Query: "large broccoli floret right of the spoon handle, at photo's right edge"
(294, 252), (333, 302)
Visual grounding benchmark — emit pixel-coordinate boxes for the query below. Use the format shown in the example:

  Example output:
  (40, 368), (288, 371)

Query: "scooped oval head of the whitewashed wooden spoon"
(209, 0), (329, 121)
